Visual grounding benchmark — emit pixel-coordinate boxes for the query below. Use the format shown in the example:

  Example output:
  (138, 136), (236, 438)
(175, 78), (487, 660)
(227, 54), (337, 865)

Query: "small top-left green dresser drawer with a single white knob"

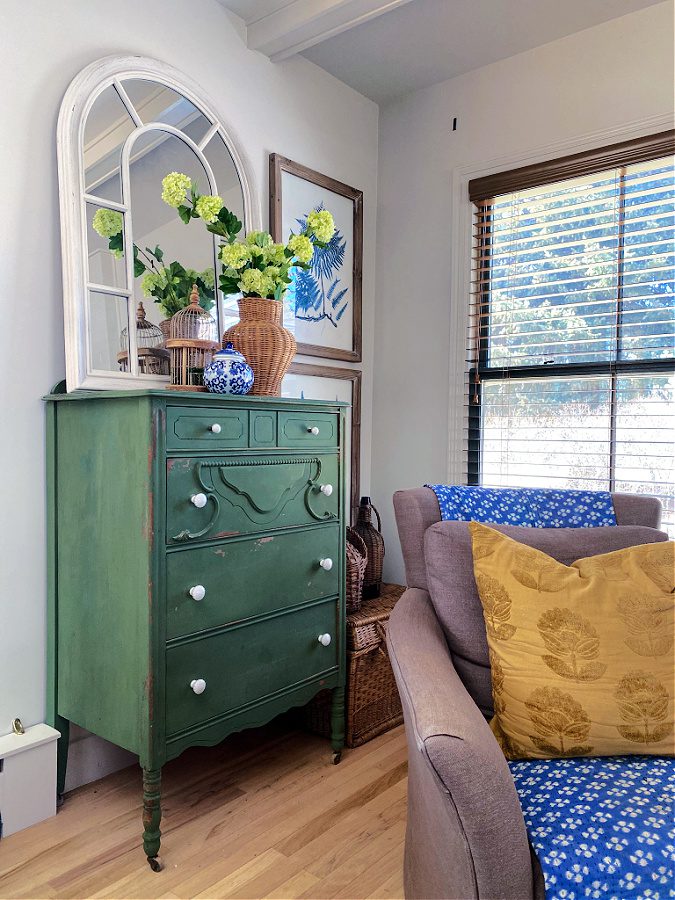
(166, 406), (249, 453)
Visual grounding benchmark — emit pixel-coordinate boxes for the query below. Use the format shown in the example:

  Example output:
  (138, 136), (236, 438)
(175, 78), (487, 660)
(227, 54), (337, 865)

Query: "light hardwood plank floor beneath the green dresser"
(0, 720), (407, 900)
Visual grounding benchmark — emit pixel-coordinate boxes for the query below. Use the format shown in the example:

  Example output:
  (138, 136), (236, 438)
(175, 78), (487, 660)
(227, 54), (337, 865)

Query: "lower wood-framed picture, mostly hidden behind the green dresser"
(281, 363), (361, 523)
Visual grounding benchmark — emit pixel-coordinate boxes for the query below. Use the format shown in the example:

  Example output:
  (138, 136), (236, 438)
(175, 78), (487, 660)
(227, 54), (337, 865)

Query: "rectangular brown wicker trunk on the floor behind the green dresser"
(305, 584), (405, 747)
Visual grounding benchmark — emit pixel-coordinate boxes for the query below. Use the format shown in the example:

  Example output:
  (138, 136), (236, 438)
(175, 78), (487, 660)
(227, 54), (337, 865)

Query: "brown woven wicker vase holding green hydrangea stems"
(223, 297), (296, 397)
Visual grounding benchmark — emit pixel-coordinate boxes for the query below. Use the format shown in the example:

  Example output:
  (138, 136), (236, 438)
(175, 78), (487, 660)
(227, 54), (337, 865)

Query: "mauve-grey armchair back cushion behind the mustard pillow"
(424, 520), (668, 715)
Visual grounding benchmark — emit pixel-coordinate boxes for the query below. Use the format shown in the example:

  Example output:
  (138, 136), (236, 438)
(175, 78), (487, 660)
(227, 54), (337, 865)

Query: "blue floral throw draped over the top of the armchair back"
(425, 484), (616, 528)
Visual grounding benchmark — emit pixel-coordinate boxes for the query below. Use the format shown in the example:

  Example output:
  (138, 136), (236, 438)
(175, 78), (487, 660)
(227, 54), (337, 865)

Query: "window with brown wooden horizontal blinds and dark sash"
(467, 132), (675, 533)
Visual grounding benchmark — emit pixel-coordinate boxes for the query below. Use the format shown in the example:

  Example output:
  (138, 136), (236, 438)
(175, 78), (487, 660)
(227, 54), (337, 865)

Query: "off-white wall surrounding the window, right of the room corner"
(372, 2), (673, 582)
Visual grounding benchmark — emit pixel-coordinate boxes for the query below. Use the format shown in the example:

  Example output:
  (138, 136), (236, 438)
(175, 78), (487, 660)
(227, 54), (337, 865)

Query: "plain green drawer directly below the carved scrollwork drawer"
(166, 524), (340, 640)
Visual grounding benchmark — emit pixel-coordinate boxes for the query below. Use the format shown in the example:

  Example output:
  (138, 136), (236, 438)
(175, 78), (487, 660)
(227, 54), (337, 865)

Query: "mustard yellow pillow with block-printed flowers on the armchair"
(469, 522), (675, 759)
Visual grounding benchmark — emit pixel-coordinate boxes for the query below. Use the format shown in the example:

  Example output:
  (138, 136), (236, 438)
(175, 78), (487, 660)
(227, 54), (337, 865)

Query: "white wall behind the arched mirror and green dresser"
(0, 0), (378, 785)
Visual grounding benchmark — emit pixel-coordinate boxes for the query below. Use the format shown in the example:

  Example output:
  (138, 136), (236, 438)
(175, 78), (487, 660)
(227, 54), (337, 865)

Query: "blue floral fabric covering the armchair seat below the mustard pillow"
(509, 756), (675, 900)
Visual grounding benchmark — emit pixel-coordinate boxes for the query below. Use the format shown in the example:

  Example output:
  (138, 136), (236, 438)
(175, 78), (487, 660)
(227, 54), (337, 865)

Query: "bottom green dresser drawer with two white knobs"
(166, 601), (338, 736)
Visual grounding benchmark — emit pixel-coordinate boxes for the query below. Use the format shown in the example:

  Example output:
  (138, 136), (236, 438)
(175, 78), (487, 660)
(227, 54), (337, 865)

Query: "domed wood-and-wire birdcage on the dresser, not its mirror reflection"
(166, 284), (218, 391)
